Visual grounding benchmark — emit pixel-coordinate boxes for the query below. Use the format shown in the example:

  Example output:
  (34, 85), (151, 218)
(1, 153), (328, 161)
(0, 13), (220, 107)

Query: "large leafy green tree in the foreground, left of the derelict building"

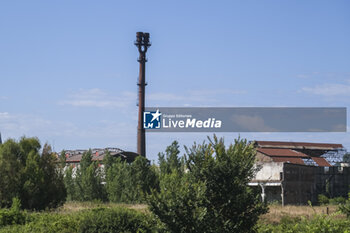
(148, 135), (267, 232)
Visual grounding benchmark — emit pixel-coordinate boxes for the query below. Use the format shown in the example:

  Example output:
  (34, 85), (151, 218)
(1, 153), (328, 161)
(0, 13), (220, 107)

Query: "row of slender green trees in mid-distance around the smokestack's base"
(61, 151), (159, 203)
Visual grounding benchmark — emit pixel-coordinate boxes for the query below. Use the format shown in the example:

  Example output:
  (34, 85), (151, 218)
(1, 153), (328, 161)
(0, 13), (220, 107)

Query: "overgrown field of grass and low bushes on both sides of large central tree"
(0, 202), (350, 233)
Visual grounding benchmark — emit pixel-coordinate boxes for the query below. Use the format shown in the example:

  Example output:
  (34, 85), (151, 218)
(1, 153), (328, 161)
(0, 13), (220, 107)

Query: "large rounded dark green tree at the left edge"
(0, 137), (66, 210)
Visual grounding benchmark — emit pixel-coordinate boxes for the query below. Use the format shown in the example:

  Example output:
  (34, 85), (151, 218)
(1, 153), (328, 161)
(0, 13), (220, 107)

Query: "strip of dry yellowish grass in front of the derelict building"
(260, 204), (346, 224)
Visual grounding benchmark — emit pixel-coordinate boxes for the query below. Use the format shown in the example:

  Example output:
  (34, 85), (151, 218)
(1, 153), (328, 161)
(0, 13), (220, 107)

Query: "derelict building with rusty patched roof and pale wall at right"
(249, 141), (350, 205)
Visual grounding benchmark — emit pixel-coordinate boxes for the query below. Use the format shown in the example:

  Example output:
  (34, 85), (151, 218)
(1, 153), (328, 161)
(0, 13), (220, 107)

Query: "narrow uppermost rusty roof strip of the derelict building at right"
(255, 141), (343, 150)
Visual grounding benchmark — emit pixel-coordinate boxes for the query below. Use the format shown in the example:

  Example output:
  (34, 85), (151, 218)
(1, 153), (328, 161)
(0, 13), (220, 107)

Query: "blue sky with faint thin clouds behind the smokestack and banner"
(0, 0), (350, 160)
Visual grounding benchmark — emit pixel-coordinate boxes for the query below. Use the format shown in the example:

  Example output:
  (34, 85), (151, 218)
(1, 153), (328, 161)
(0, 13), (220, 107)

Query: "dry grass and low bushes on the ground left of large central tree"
(0, 202), (162, 233)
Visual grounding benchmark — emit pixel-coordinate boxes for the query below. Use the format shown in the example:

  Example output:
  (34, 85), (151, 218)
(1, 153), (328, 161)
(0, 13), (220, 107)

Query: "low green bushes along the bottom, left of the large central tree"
(0, 207), (159, 233)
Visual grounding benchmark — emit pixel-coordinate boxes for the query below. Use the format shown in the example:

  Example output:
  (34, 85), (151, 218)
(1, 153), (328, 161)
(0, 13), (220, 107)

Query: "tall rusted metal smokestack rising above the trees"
(135, 32), (151, 157)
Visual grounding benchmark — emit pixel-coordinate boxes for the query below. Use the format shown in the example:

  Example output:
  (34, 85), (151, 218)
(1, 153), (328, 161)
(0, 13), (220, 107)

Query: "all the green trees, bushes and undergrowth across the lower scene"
(4, 136), (350, 233)
